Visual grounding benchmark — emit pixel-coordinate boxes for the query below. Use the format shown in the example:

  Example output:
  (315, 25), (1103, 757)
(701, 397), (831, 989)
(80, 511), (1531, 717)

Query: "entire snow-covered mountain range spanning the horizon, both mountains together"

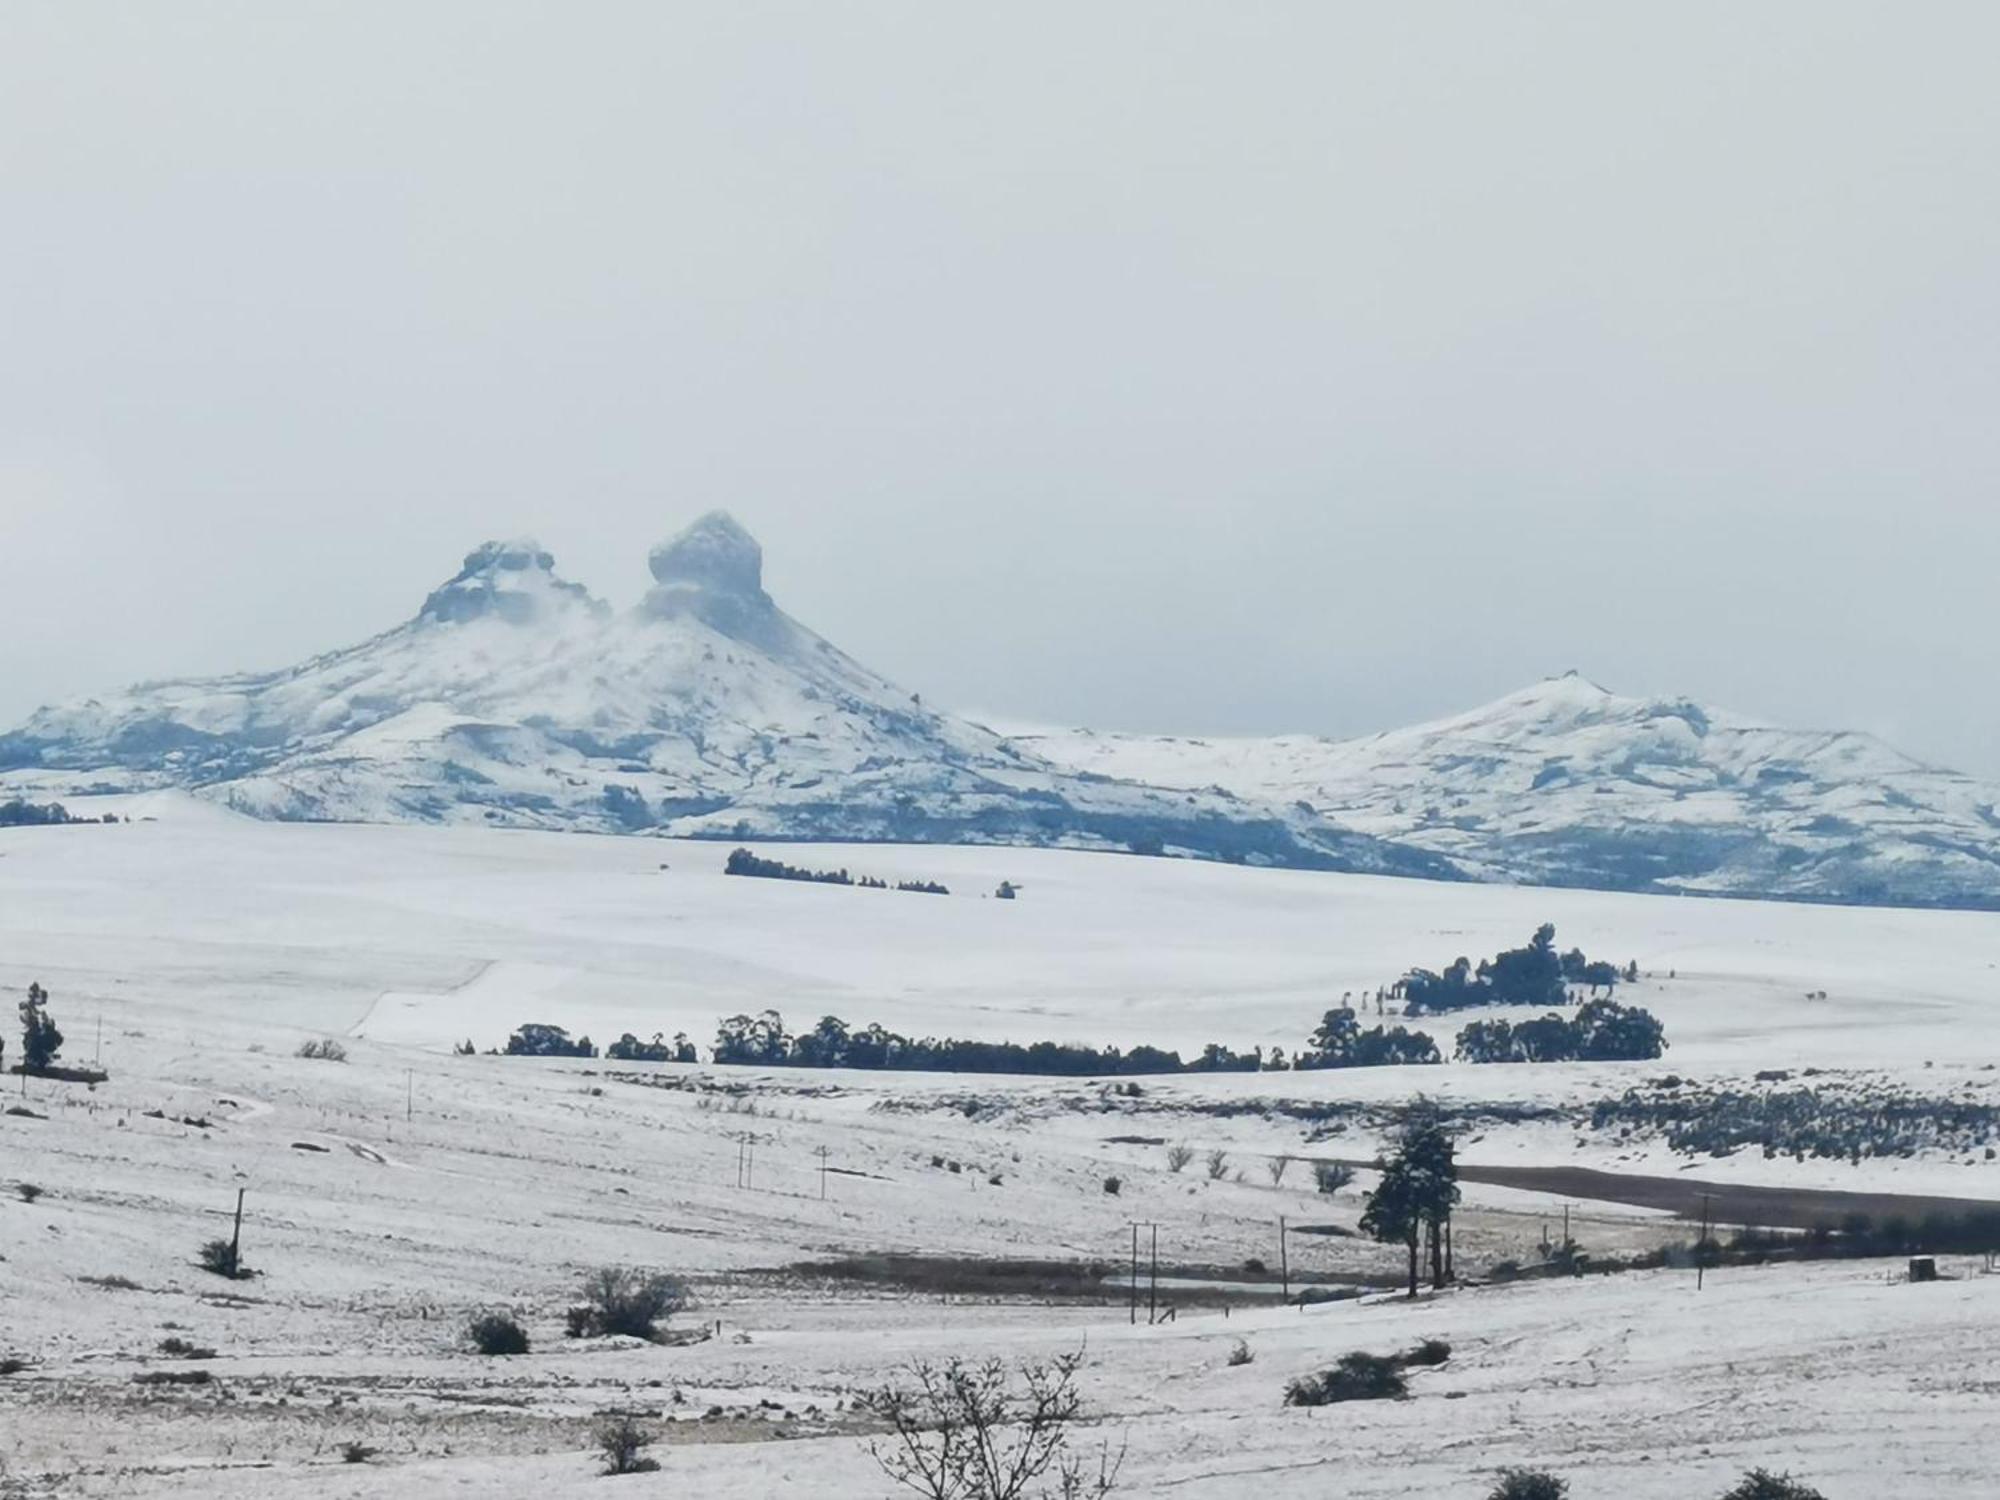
(0, 512), (2000, 908)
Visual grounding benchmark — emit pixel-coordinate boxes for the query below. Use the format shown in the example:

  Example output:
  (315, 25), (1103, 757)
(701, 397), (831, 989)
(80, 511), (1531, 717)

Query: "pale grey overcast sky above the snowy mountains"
(0, 0), (2000, 776)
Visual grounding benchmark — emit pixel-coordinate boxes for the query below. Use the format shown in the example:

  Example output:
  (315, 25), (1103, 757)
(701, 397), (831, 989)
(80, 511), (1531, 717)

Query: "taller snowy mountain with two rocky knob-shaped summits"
(0, 512), (1456, 876)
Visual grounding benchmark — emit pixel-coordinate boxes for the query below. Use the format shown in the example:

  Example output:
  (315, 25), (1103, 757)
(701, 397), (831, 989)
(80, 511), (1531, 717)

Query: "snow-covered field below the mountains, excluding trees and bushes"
(0, 816), (2000, 1500)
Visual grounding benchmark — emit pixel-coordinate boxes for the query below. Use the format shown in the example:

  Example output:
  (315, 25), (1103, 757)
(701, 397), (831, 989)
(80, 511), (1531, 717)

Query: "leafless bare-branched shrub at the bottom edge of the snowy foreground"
(868, 1350), (1124, 1500)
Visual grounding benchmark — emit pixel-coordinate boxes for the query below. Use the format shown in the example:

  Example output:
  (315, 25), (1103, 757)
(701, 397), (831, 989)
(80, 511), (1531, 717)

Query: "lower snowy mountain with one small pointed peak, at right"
(1016, 672), (2000, 906)
